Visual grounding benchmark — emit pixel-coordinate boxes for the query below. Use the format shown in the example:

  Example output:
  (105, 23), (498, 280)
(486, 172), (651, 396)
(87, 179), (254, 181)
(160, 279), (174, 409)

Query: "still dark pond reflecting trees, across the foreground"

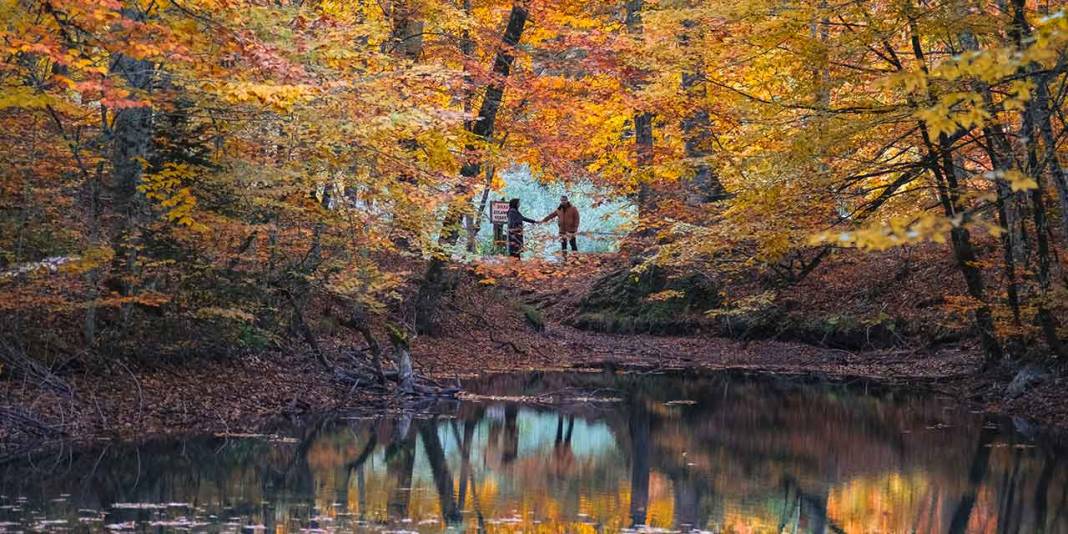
(0, 374), (1068, 533)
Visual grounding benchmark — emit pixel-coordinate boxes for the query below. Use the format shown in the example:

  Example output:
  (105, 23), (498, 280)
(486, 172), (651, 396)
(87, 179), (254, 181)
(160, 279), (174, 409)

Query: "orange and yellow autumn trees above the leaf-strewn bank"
(0, 0), (1068, 362)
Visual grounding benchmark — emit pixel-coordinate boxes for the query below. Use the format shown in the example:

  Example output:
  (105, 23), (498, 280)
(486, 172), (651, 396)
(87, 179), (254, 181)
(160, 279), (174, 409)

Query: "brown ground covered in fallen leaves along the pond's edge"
(0, 250), (1068, 458)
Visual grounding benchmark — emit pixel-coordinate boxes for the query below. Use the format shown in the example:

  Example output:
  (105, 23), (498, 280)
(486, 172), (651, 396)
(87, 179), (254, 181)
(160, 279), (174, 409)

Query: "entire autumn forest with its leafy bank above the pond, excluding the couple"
(0, 0), (1068, 532)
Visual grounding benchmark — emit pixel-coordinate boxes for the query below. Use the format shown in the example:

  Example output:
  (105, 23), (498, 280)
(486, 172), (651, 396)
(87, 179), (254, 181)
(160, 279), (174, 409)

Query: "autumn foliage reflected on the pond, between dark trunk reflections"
(0, 373), (1068, 532)
